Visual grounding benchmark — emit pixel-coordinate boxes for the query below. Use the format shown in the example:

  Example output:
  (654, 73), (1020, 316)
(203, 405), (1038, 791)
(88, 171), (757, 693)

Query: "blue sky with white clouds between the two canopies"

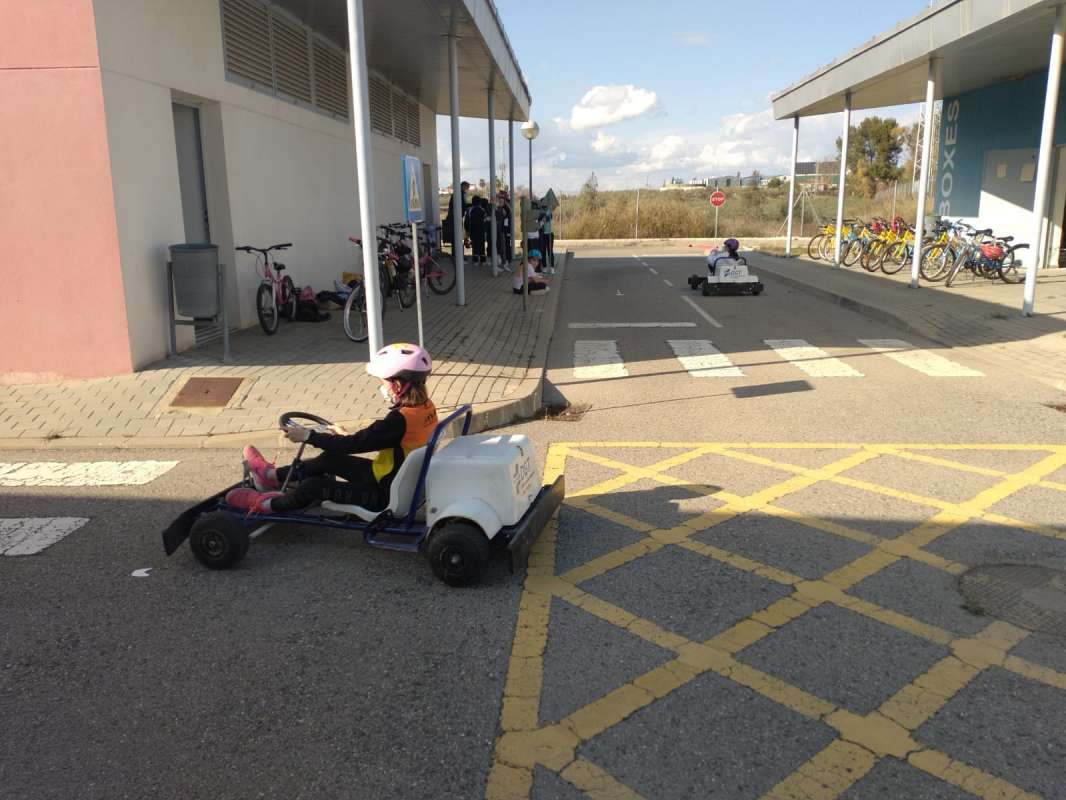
(437, 0), (928, 194)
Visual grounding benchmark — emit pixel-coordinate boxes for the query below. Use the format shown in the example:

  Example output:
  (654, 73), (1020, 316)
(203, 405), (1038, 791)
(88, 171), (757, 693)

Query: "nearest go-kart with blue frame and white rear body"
(163, 405), (565, 586)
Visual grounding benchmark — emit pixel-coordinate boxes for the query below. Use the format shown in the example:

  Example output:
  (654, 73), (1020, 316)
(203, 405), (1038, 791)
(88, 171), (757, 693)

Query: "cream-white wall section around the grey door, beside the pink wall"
(94, 0), (437, 367)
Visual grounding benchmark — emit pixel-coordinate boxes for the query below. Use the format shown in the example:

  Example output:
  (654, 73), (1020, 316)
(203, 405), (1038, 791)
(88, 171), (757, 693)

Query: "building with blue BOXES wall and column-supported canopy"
(773, 0), (1066, 314)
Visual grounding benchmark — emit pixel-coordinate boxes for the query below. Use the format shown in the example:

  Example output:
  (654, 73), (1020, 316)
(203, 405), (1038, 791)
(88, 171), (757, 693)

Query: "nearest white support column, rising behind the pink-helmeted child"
(348, 0), (384, 353)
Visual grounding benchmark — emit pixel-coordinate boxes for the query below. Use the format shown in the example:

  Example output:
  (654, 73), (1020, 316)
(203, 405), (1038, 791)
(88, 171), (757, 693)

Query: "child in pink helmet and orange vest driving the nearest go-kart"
(226, 345), (437, 513)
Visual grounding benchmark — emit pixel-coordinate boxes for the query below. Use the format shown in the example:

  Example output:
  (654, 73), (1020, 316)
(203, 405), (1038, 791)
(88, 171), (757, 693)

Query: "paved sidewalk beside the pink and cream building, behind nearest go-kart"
(0, 257), (567, 447)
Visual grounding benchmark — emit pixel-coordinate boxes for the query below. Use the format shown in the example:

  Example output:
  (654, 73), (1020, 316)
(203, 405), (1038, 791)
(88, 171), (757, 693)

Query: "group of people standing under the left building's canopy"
(443, 180), (555, 272)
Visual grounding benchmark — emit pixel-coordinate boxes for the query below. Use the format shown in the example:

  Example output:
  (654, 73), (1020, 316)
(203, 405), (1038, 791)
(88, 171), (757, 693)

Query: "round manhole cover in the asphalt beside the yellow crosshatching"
(958, 564), (1066, 637)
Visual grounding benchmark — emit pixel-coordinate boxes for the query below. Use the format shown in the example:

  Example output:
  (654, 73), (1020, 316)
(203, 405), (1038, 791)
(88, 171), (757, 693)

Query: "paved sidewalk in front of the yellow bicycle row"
(748, 254), (1066, 390)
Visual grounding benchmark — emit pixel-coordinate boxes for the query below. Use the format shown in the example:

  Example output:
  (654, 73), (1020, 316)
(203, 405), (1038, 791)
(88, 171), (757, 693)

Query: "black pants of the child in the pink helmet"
(271, 453), (389, 511)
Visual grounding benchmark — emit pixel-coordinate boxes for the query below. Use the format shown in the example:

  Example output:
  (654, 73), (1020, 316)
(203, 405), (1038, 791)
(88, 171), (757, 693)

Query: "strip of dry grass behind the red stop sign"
(555, 188), (917, 239)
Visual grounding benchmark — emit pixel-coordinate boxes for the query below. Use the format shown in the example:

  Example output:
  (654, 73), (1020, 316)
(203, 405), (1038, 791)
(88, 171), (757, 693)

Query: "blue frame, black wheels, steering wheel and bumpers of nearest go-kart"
(163, 404), (566, 585)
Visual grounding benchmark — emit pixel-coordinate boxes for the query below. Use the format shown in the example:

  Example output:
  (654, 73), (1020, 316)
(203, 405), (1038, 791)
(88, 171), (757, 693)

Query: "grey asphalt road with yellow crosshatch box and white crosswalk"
(0, 251), (1066, 800)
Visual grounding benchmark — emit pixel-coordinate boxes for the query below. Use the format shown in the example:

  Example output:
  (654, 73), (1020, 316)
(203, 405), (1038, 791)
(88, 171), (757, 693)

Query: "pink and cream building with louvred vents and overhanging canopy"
(0, 0), (530, 383)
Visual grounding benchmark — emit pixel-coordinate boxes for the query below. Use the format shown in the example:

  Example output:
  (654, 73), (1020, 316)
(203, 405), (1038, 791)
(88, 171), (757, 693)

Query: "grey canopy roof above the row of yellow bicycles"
(771, 0), (1055, 119)
